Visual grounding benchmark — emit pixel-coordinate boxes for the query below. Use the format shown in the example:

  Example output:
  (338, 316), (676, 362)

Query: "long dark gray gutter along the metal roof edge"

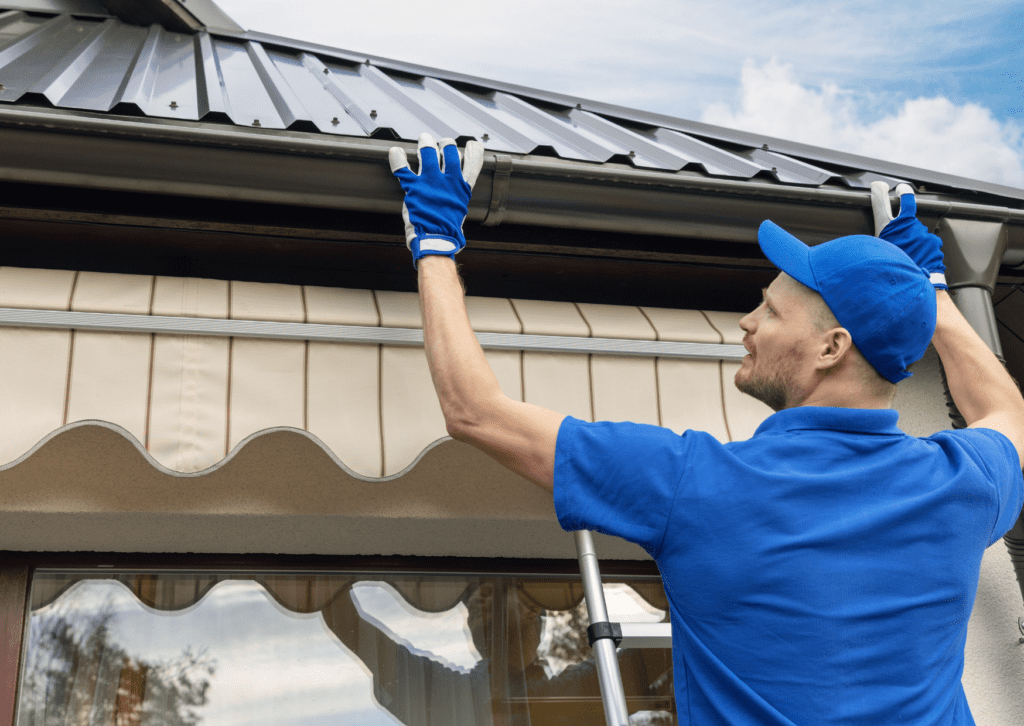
(0, 106), (1024, 266)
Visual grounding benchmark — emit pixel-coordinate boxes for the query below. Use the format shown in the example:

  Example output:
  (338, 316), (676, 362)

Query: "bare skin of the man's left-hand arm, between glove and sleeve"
(418, 255), (565, 492)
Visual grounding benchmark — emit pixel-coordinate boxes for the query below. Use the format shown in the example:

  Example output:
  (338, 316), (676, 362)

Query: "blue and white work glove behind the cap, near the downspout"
(871, 181), (949, 290)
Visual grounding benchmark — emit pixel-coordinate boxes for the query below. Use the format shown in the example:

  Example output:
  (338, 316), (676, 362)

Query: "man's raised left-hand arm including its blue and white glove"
(390, 134), (565, 492)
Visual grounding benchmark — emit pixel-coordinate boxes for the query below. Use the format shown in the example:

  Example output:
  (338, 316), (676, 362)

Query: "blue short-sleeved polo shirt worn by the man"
(554, 407), (1024, 726)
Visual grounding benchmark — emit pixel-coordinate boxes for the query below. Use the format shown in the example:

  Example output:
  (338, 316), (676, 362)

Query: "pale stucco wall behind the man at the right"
(895, 347), (1024, 726)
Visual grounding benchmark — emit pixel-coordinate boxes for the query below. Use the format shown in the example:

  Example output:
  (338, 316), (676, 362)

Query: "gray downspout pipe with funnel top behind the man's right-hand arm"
(935, 217), (1024, 600)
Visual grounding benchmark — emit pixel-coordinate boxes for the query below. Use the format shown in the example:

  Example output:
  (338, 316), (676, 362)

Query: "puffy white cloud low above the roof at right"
(701, 60), (1024, 187)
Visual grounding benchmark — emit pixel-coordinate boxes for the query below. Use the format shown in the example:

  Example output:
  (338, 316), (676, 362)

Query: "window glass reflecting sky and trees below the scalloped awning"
(17, 570), (675, 726)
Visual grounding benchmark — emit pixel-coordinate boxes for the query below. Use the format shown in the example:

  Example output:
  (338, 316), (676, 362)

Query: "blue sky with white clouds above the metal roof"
(211, 0), (1024, 187)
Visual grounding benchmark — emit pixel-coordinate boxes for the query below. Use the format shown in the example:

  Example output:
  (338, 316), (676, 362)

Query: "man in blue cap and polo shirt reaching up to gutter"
(391, 135), (1024, 726)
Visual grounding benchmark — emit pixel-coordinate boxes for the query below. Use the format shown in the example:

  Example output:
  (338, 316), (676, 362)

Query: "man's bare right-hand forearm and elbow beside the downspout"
(932, 290), (1024, 462)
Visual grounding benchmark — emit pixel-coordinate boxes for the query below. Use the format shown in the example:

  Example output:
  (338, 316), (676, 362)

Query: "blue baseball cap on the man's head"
(758, 220), (936, 383)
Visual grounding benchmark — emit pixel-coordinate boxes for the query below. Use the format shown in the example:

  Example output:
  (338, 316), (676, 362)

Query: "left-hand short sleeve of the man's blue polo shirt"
(554, 417), (689, 557)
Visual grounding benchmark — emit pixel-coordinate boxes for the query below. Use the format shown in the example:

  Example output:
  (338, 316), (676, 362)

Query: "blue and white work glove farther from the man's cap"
(388, 133), (483, 267)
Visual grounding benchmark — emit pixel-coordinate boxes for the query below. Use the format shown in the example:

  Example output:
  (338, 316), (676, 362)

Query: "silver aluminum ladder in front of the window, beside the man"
(572, 529), (672, 726)
